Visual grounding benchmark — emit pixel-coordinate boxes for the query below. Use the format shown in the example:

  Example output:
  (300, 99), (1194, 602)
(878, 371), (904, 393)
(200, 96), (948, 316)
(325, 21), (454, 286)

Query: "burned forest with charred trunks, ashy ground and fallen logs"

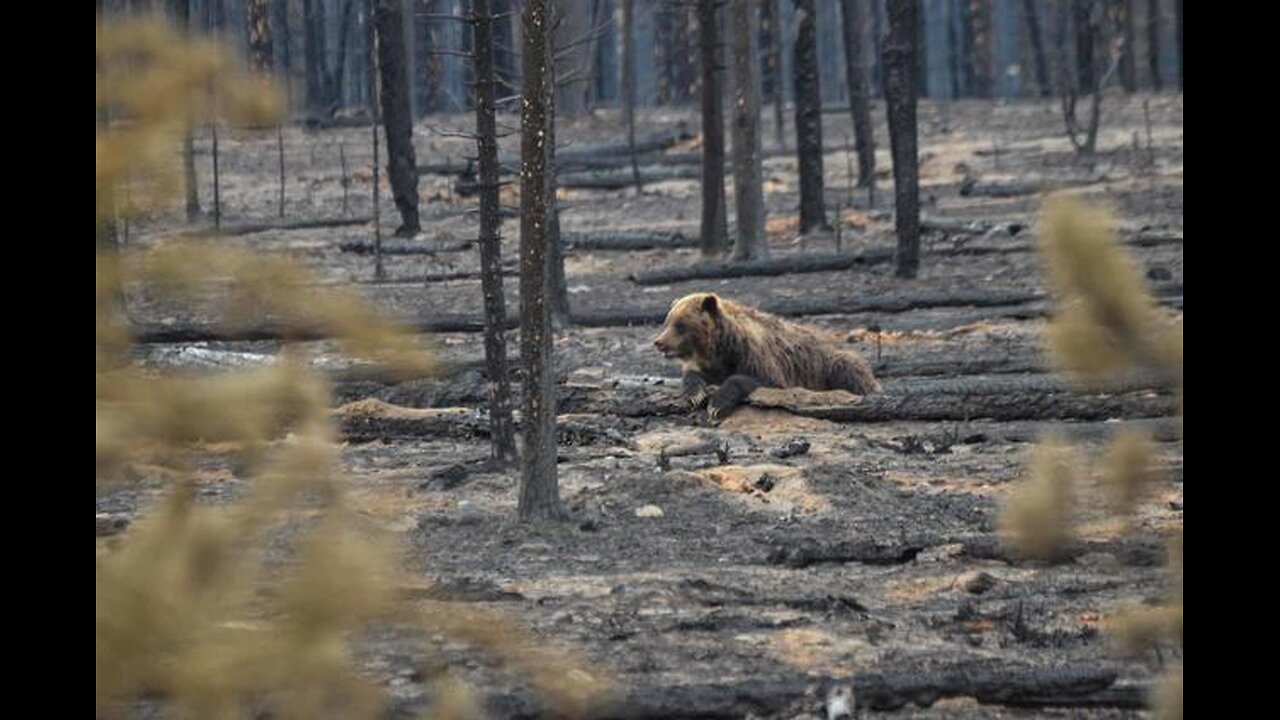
(96, 0), (1185, 720)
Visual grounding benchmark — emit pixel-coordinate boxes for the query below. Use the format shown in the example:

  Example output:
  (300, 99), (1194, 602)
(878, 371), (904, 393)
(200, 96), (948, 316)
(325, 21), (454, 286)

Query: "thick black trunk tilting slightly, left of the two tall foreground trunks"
(374, 0), (422, 237)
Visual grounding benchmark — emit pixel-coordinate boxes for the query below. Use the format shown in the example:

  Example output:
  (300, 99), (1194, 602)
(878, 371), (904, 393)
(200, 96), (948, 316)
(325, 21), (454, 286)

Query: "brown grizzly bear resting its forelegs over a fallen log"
(653, 292), (881, 421)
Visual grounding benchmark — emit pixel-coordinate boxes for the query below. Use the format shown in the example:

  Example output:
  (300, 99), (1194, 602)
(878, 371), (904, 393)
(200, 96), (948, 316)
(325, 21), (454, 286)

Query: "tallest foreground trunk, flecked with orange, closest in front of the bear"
(517, 0), (566, 520)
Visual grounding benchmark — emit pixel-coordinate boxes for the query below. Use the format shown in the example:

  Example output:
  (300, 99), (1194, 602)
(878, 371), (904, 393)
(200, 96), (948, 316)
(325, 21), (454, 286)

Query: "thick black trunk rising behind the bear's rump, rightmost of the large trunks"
(884, 0), (920, 278)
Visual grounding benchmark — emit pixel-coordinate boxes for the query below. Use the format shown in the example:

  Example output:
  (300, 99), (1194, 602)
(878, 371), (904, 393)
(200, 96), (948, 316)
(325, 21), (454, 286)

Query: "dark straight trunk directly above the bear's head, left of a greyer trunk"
(701, 0), (728, 258)
